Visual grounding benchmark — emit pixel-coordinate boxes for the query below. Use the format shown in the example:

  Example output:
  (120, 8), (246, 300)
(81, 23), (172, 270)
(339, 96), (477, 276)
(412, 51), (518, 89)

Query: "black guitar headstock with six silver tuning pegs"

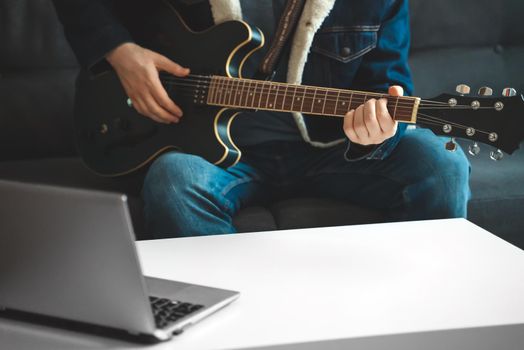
(416, 85), (524, 160)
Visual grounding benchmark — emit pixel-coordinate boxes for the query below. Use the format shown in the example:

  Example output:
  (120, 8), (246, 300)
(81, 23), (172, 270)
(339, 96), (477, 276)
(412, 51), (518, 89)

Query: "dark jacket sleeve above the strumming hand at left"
(53, 0), (133, 72)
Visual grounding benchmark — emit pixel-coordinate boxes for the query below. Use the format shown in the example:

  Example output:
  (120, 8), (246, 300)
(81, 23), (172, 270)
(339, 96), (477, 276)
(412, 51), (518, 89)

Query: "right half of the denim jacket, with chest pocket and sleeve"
(303, 0), (413, 160)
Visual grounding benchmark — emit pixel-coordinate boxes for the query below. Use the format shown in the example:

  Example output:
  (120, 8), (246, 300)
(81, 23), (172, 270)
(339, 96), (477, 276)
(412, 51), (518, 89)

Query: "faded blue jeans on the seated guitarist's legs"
(143, 129), (470, 238)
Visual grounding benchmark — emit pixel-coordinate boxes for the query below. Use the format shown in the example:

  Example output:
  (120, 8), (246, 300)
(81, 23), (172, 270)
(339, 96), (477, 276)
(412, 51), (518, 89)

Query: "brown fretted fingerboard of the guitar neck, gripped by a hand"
(205, 76), (420, 123)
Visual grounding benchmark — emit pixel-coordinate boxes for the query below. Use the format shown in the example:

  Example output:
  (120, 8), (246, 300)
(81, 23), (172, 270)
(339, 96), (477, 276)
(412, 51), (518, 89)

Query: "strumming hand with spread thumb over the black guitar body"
(106, 43), (189, 124)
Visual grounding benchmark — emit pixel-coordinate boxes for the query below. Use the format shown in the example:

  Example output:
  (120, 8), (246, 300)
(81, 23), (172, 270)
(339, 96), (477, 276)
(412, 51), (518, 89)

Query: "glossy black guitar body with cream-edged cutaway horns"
(74, 1), (263, 176)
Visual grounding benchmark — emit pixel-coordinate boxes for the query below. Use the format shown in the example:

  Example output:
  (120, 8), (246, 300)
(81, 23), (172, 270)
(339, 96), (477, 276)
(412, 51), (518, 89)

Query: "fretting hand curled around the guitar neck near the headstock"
(344, 85), (404, 146)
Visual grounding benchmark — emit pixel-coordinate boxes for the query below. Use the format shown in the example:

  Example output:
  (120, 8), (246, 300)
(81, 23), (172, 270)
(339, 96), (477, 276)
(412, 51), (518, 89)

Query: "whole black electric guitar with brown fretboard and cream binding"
(74, 2), (524, 176)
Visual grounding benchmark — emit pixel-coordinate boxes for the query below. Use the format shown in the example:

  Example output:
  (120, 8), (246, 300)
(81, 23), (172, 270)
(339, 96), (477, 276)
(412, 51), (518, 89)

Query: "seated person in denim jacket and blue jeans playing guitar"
(54, 0), (470, 238)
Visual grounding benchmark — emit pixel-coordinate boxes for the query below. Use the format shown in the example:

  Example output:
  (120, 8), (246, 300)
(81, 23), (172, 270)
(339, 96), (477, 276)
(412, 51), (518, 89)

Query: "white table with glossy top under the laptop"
(0, 219), (524, 350)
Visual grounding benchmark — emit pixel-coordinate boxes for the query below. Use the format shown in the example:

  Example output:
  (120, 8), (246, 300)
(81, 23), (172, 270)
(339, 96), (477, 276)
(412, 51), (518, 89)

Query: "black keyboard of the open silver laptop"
(149, 296), (204, 328)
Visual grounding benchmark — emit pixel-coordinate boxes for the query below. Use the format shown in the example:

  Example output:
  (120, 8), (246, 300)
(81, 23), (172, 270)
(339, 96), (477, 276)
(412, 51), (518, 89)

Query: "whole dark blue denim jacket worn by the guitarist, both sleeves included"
(53, 0), (412, 160)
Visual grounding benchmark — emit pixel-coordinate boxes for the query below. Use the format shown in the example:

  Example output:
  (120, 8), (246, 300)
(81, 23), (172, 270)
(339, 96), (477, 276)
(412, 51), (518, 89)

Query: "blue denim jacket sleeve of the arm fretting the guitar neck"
(345, 0), (413, 161)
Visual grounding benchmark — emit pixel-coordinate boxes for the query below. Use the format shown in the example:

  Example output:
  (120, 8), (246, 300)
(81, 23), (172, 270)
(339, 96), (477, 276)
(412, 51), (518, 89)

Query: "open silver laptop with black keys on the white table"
(0, 180), (239, 341)
